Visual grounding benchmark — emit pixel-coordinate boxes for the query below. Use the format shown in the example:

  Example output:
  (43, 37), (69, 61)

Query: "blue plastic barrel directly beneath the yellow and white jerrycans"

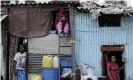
(42, 69), (59, 80)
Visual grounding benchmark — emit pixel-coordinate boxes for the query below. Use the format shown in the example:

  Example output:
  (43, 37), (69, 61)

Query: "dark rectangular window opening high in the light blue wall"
(98, 14), (121, 27)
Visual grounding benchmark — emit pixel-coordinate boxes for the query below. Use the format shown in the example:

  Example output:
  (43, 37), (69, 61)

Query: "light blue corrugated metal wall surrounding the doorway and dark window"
(75, 13), (133, 80)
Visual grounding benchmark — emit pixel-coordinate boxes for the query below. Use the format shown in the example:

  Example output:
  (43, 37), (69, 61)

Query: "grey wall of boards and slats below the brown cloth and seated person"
(28, 34), (71, 80)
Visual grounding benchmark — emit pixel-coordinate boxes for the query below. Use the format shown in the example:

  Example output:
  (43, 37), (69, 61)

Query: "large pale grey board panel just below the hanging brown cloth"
(28, 34), (59, 54)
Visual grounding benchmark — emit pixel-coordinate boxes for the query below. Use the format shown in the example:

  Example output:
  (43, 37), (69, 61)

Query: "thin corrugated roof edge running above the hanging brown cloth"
(1, 0), (79, 6)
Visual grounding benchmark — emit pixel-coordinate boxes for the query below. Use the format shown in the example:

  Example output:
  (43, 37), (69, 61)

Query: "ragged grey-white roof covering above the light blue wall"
(77, 1), (133, 18)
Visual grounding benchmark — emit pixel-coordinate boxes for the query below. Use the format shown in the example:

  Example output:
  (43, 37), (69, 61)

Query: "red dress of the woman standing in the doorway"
(107, 62), (120, 80)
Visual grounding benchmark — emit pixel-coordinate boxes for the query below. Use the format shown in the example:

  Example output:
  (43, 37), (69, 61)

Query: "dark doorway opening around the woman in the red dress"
(102, 46), (125, 80)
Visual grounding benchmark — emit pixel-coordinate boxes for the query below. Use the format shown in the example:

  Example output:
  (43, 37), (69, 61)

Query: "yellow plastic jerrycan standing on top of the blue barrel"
(42, 55), (53, 68)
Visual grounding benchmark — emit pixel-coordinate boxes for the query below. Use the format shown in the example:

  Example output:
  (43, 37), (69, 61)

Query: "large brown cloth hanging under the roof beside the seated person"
(9, 7), (53, 38)
